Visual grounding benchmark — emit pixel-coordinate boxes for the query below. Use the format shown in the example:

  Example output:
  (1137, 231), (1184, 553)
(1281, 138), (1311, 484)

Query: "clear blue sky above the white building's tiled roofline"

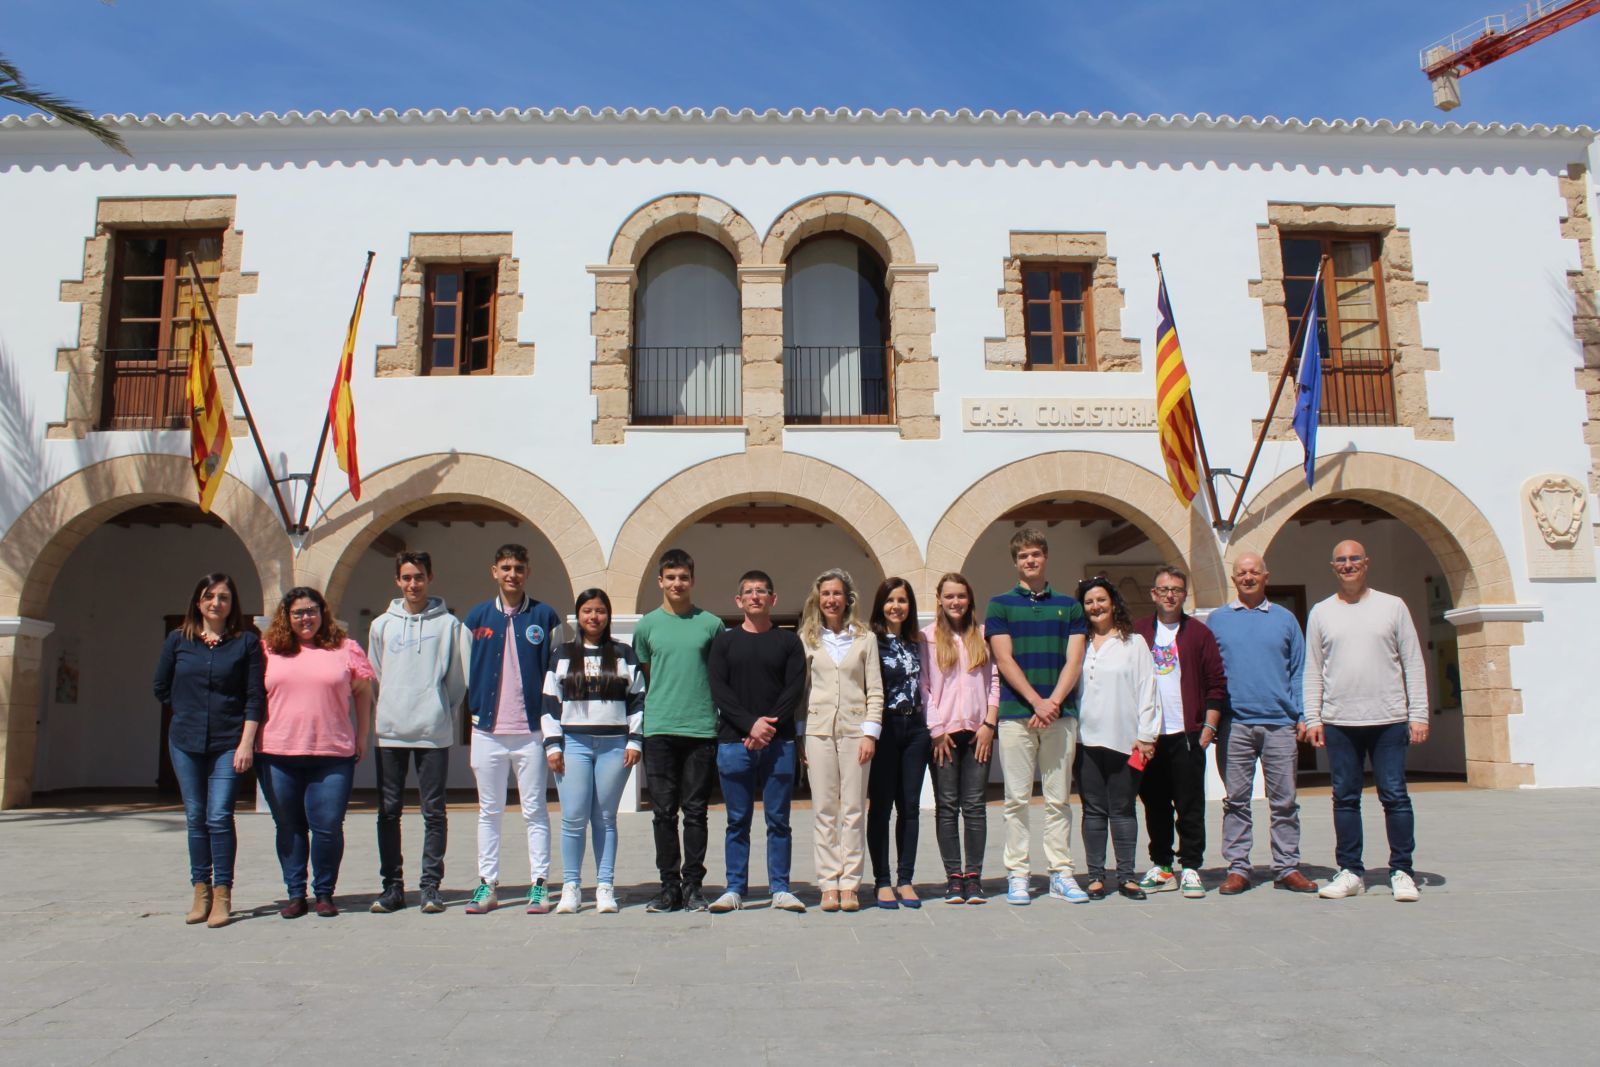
(0, 0), (1600, 125)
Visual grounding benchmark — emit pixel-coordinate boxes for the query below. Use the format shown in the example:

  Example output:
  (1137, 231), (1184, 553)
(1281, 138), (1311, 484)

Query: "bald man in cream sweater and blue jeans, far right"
(1306, 541), (1427, 902)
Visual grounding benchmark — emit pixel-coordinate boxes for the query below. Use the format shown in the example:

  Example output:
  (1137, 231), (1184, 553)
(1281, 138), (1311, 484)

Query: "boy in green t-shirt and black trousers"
(634, 549), (723, 912)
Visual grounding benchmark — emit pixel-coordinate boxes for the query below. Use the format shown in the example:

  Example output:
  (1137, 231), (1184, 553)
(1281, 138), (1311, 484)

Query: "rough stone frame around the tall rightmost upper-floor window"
(1248, 200), (1456, 442)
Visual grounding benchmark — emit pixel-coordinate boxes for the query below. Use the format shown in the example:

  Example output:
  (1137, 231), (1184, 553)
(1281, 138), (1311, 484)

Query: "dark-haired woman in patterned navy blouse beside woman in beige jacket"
(867, 577), (933, 909)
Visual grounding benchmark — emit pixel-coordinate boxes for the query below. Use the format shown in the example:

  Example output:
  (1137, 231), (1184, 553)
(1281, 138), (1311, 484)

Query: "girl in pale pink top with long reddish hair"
(922, 573), (1000, 904)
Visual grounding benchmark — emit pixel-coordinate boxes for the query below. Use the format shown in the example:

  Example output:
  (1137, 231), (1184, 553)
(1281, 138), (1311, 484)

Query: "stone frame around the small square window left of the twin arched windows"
(374, 230), (534, 378)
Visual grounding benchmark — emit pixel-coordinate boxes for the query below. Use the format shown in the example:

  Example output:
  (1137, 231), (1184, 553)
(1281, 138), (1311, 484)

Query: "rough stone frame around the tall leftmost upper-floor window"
(45, 195), (259, 440)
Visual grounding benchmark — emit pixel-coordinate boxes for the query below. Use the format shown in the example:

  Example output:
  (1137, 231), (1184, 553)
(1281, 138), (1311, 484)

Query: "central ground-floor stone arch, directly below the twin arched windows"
(606, 451), (923, 614)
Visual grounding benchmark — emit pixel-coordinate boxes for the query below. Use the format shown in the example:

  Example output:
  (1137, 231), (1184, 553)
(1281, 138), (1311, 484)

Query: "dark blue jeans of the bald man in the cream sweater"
(1323, 723), (1416, 875)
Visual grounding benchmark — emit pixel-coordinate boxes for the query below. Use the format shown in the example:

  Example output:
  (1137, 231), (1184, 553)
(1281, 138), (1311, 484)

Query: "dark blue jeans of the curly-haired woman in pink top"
(256, 755), (355, 899)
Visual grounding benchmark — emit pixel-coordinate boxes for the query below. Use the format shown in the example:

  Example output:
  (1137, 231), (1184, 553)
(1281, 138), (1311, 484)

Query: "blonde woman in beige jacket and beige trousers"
(800, 568), (883, 912)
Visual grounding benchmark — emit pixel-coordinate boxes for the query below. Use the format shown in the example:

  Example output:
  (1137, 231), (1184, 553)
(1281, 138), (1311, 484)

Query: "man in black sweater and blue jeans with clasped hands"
(709, 571), (805, 913)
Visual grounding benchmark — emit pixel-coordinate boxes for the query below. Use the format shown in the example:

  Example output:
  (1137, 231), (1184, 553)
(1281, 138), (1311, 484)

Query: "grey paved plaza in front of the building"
(0, 790), (1600, 1067)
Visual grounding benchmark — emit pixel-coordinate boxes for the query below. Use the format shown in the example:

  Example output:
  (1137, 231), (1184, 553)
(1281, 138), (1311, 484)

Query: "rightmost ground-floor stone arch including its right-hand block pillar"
(1227, 453), (1533, 789)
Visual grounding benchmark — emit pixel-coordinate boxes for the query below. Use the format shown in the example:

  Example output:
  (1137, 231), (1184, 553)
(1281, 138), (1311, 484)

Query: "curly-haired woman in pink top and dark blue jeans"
(256, 585), (373, 918)
